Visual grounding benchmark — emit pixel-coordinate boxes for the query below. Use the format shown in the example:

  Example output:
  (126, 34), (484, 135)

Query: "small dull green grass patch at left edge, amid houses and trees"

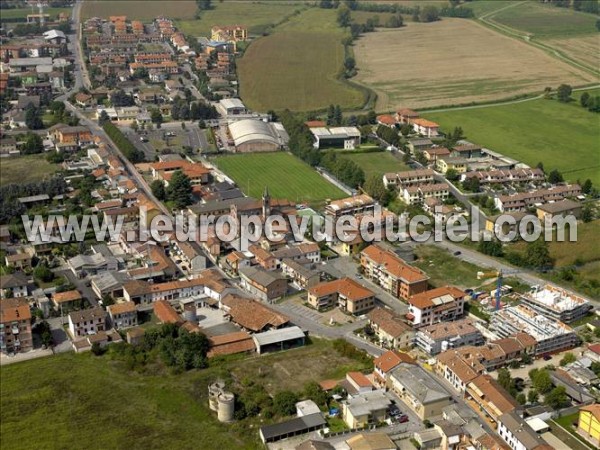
(0, 155), (60, 185)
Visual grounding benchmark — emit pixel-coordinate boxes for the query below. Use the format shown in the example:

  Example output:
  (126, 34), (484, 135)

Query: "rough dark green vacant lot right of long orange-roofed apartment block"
(415, 245), (482, 289)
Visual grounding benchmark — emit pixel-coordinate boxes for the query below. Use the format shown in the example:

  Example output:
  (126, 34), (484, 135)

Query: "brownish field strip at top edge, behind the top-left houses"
(81, 0), (198, 21)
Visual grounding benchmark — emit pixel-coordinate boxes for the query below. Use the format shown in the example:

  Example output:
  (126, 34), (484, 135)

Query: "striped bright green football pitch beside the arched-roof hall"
(216, 152), (347, 203)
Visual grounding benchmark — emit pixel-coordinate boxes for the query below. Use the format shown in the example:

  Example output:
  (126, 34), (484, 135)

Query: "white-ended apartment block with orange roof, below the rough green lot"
(406, 286), (466, 328)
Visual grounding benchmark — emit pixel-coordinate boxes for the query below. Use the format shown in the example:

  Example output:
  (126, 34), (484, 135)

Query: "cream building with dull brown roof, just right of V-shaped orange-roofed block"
(367, 307), (415, 349)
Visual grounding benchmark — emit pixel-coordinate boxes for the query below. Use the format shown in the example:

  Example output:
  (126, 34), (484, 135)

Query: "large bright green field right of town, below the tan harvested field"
(424, 90), (600, 186)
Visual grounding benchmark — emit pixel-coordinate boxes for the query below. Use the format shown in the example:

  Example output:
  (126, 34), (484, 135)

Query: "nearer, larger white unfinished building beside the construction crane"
(491, 305), (578, 355)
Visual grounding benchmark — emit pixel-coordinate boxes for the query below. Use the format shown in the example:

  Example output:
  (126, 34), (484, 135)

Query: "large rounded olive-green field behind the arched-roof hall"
(237, 8), (365, 111)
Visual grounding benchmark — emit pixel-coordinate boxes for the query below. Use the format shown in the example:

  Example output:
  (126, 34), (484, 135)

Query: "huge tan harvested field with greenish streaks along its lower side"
(354, 18), (598, 111)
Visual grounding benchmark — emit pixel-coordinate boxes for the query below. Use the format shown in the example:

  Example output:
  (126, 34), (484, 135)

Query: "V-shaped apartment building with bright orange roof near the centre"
(307, 277), (375, 315)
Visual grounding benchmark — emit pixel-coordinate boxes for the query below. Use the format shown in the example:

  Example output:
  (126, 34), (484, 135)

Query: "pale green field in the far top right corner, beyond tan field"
(488, 1), (597, 37)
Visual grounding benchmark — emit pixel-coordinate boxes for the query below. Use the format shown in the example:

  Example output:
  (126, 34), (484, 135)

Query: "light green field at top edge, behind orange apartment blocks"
(177, 1), (305, 36)
